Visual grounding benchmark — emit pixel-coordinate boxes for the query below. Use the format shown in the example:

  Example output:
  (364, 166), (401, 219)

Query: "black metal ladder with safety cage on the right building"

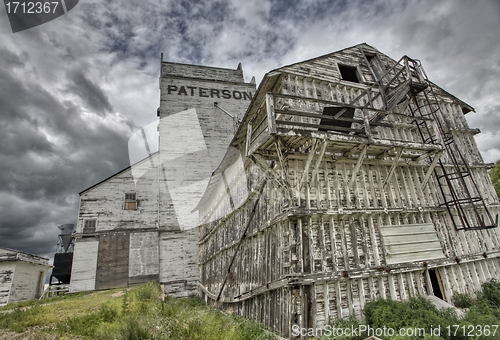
(353, 49), (498, 230)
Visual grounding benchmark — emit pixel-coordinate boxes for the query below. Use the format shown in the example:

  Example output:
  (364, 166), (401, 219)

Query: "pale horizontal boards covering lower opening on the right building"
(380, 223), (444, 264)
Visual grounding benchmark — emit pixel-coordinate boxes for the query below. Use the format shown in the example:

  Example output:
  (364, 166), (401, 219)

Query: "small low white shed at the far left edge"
(0, 247), (52, 307)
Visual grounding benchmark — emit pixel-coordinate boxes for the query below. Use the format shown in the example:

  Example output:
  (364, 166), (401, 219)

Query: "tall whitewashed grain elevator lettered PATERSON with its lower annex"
(70, 57), (255, 296)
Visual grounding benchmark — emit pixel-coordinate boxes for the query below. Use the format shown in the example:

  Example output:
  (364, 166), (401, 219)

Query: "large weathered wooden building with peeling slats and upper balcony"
(198, 44), (500, 336)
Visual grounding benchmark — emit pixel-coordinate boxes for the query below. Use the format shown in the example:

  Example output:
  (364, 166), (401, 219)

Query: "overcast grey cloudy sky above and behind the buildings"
(0, 0), (500, 258)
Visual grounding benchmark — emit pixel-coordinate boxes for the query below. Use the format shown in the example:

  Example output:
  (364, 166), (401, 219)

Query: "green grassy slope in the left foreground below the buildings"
(0, 282), (275, 340)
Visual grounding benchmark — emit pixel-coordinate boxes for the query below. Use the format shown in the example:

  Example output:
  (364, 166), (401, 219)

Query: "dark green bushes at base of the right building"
(321, 280), (500, 340)
